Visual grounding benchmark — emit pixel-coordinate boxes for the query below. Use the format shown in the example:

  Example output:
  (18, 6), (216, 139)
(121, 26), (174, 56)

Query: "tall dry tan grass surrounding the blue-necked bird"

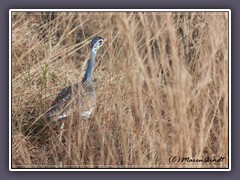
(12, 12), (228, 168)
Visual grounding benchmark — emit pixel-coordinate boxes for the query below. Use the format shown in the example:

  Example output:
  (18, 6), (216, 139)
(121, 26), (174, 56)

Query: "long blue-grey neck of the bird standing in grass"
(82, 50), (97, 83)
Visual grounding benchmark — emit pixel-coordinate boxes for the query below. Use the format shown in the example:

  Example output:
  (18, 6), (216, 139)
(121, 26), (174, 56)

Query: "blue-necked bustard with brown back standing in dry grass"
(47, 36), (104, 124)
